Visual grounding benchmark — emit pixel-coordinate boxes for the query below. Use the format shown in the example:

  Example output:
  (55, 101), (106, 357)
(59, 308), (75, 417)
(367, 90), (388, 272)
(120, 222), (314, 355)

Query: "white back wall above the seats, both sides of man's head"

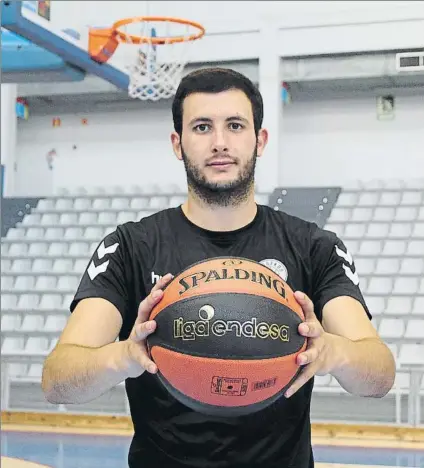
(17, 91), (424, 195)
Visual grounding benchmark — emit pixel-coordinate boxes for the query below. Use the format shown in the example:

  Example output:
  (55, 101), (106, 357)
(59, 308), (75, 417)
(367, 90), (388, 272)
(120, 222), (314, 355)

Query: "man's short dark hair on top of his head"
(172, 68), (264, 137)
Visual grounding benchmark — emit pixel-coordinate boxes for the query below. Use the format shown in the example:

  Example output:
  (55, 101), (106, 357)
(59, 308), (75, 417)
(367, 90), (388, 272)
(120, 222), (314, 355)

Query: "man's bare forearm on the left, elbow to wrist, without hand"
(42, 342), (128, 404)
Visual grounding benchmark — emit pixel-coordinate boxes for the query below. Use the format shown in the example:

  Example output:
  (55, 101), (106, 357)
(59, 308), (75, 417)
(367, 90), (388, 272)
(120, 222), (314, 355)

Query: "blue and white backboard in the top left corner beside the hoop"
(1, 1), (129, 90)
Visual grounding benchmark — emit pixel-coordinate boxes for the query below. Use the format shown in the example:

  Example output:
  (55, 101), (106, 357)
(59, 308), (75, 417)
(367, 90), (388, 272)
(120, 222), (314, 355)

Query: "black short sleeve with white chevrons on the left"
(70, 229), (129, 319)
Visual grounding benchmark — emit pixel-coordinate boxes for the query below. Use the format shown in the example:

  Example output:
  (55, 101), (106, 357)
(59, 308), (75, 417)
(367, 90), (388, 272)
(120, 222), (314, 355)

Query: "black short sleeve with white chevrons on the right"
(310, 227), (372, 320)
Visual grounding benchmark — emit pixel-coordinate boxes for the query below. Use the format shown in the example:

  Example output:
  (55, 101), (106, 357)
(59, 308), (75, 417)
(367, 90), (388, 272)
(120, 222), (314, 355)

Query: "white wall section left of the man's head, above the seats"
(17, 109), (185, 195)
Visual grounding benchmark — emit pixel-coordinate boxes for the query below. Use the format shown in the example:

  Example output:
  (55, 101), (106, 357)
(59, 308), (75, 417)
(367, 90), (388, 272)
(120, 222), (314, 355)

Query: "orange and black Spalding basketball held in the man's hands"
(147, 257), (306, 417)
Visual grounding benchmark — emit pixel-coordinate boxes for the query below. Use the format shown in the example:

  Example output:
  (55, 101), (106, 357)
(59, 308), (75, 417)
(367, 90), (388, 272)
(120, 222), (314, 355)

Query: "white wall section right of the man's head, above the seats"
(280, 94), (424, 186)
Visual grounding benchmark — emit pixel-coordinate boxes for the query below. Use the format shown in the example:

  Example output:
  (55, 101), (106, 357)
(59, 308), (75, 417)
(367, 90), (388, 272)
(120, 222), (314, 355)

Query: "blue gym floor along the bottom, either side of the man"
(1, 428), (424, 468)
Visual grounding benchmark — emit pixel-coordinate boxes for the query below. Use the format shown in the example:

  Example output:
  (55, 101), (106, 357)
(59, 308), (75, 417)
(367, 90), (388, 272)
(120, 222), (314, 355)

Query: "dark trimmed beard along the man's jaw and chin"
(181, 145), (257, 206)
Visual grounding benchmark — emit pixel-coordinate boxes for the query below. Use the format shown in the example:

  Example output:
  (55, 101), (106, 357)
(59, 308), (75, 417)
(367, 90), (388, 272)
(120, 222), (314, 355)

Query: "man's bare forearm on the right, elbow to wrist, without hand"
(331, 335), (396, 397)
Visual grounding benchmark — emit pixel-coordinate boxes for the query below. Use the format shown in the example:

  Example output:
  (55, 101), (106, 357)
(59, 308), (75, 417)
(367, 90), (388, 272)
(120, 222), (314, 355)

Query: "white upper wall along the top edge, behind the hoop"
(46, 0), (424, 67)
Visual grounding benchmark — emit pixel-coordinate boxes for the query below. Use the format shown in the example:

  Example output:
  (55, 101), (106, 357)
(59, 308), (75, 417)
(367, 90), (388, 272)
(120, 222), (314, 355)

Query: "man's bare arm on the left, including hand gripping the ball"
(42, 275), (171, 404)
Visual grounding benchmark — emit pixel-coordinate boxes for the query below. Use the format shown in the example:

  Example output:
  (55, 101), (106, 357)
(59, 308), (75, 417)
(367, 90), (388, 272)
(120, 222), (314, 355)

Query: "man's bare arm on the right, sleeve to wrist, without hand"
(322, 296), (396, 397)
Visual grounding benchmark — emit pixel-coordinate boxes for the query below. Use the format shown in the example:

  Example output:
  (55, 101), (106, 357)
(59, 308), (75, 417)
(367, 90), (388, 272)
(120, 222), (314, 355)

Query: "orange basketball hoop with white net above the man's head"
(89, 16), (205, 101)
